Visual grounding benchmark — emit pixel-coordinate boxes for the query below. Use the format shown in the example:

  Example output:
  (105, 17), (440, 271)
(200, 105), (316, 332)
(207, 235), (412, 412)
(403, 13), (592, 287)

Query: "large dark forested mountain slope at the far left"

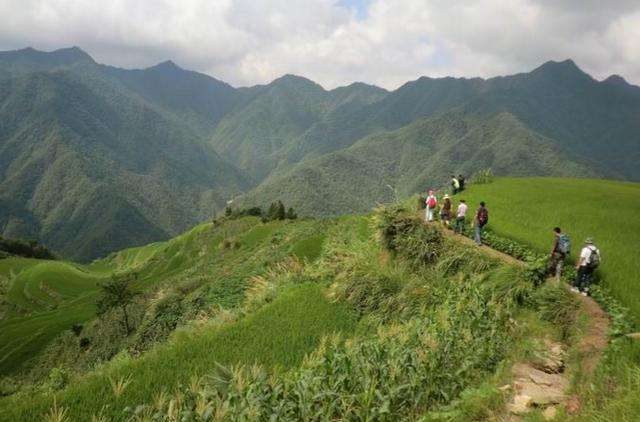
(0, 48), (248, 260)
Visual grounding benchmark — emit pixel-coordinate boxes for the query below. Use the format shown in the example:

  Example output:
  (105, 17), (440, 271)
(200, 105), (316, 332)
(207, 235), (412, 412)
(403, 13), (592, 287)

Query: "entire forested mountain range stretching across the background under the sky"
(0, 47), (640, 261)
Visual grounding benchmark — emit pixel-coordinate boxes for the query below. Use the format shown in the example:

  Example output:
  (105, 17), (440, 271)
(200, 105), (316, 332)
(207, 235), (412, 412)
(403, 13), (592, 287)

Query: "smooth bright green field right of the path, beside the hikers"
(456, 178), (640, 319)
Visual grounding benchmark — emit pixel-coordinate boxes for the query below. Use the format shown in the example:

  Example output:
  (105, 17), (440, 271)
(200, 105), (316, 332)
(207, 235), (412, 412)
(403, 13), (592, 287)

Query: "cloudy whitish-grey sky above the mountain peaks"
(0, 0), (640, 88)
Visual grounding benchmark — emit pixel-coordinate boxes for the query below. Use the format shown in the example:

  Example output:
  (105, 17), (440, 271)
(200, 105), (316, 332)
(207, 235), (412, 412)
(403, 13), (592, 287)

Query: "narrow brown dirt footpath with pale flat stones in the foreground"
(425, 218), (610, 421)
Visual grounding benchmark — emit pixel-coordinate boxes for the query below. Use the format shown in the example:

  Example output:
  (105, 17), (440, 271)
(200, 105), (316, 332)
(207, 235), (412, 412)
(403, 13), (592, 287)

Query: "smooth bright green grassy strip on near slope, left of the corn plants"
(0, 284), (356, 420)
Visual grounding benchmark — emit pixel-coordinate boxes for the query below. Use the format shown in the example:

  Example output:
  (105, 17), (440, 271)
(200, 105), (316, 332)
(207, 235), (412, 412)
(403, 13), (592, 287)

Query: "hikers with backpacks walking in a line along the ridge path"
(424, 175), (602, 296)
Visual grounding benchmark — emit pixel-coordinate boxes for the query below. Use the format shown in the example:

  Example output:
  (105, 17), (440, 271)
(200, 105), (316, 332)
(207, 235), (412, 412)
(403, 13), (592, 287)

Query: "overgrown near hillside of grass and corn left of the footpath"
(0, 206), (576, 420)
